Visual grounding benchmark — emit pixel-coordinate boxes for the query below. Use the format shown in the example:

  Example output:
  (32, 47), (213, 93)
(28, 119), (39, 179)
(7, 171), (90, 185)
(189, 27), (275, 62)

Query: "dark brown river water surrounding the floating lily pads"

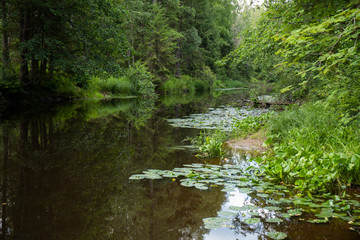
(0, 90), (360, 240)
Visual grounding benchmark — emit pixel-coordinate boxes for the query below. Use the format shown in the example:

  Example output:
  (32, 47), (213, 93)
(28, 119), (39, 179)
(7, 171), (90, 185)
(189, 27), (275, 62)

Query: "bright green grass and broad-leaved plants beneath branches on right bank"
(262, 102), (360, 194)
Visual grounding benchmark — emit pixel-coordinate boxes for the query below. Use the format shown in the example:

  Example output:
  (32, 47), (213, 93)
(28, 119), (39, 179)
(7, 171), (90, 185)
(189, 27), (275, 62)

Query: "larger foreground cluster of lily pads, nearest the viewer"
(129, 162), (360, 236)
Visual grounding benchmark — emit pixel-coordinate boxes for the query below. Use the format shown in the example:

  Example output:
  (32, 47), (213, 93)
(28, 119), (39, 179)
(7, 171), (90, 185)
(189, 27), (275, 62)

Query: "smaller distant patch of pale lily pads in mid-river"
(167, 106), (267, 131)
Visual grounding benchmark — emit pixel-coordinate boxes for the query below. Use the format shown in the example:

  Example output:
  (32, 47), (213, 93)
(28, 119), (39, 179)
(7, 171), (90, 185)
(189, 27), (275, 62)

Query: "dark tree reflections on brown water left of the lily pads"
(0, 102), (229, 240)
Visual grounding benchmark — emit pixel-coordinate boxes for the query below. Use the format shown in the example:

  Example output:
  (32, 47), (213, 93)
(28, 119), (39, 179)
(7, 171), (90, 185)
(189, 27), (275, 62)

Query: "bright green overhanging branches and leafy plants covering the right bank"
(218, 0), (360, 194)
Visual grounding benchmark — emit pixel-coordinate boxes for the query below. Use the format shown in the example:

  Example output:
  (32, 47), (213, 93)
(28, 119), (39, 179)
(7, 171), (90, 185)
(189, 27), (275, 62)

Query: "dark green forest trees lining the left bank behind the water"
(0, 0), (237, 99)
